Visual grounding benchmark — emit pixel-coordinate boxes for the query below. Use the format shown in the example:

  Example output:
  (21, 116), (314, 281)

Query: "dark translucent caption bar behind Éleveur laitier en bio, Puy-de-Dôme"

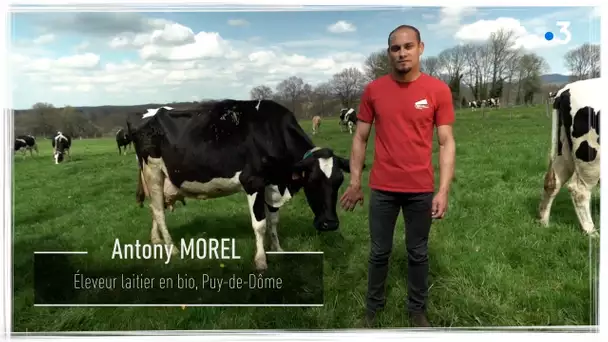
(34, 253), (323, 305)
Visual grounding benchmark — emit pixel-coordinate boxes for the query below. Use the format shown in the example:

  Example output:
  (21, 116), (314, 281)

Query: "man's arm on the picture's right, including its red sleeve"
(433, 85), (456, 217)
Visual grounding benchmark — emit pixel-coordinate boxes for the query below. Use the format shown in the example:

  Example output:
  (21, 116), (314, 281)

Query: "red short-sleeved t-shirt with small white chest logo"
(357, 73), (454, 192)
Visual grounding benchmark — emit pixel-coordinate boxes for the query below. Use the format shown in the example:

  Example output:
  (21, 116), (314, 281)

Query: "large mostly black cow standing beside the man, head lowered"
(127, 99), (350, 271)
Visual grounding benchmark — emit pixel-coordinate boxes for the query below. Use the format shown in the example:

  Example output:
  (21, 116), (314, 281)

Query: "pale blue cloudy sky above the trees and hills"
(9, 7), (600, 109)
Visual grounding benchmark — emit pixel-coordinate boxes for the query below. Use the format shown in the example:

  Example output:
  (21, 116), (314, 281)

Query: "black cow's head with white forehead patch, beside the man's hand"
(293, 148), (360, 231)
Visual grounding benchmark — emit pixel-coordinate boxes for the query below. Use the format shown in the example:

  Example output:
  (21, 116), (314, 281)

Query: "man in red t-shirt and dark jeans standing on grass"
(340, 25), (455, 326)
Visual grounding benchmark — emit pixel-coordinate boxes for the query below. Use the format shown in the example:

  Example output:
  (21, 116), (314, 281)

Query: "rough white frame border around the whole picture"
(0, 0), (608, 341)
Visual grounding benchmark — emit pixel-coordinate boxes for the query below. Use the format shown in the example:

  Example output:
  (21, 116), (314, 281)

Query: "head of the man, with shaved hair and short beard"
(388, 29), (424, 74)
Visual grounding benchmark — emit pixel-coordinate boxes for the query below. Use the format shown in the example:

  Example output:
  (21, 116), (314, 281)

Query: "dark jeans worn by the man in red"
(367, 189), (433, 312)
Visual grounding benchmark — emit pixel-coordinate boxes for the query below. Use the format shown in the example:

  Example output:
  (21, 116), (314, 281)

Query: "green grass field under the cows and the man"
(13, 106), (599, 331)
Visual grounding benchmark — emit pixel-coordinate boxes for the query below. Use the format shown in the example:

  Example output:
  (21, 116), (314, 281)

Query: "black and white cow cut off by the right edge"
(539, 78), (604, 235)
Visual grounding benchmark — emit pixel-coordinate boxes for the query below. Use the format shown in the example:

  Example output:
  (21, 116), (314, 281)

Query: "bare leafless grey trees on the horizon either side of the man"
(250, 30), (600, 118)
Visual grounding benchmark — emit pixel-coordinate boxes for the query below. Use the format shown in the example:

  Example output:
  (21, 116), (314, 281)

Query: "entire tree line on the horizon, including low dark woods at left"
(14, 30), (600, 138)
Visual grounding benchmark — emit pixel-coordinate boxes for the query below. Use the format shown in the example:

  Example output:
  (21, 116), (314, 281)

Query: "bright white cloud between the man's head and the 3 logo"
(454, 17), (563, 50)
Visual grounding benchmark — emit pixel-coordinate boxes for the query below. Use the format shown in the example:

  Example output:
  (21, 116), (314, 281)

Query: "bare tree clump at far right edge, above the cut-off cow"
(564, 43), (600, 80)
